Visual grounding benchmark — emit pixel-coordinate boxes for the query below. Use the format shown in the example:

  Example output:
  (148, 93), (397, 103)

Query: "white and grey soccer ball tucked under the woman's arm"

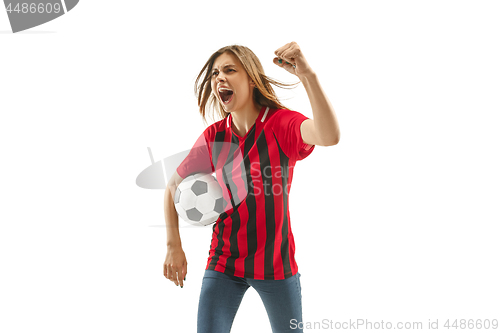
(174, 173), (224, 226)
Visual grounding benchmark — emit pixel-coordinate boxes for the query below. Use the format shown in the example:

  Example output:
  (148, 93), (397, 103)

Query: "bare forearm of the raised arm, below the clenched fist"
(299, 72), (340, 144)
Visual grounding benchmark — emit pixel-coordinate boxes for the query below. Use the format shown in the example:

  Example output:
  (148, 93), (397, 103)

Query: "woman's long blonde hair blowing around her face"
(194, 45), (299, 122)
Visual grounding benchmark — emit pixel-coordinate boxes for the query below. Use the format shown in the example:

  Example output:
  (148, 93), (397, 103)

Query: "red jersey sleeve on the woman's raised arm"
(273, 110), (315, 161)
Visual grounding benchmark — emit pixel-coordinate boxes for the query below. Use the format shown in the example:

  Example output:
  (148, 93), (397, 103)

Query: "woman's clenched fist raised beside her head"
(273, 42), (314, 79)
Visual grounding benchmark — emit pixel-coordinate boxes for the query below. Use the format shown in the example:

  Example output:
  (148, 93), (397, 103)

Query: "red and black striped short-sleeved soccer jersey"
(177, 107), (314, 280)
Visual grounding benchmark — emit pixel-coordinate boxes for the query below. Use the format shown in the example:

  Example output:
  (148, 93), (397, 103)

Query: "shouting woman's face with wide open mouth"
(211, 52), (255, 112)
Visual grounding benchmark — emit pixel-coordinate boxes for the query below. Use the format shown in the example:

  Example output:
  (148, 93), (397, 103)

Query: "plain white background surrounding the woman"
(0, 0), (500, 332)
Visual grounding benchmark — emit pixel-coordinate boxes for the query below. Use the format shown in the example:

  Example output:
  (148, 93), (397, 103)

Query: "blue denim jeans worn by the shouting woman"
(198, 270), (302, 333)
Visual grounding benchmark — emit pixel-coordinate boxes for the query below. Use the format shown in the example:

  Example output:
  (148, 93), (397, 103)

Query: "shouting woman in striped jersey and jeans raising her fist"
(164, 42), (340, 333)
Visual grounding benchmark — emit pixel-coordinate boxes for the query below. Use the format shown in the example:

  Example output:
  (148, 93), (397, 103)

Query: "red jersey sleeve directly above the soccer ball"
(177, 130), (214, 178)
